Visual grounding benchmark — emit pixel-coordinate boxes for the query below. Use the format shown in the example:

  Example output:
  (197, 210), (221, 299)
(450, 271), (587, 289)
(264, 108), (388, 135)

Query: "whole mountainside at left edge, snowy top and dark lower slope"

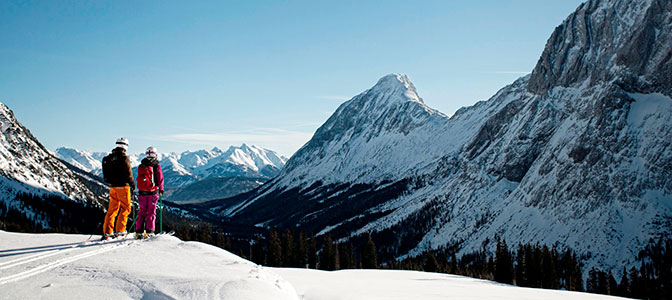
(0, 103), (105, 229)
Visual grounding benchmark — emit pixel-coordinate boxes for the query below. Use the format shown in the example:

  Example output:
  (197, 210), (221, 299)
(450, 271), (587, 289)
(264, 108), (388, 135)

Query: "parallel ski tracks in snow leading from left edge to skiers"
(0, 239), (136, 285)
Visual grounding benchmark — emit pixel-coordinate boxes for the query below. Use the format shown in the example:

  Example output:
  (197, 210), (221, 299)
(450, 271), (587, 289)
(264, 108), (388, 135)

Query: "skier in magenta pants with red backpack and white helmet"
(135, 147), (163, 238)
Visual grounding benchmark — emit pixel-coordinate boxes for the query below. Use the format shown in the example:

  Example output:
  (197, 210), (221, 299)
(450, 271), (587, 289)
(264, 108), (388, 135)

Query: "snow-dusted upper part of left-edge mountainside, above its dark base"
(0, 103), (102, 210)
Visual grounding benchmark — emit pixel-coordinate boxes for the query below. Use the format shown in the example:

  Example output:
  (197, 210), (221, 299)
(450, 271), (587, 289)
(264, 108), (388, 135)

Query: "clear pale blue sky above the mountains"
(0, 0), (583, 156)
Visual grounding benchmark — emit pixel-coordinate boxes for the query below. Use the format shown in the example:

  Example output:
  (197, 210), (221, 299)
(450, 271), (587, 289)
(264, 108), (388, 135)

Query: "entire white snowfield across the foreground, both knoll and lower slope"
(0, 231), (632, 300)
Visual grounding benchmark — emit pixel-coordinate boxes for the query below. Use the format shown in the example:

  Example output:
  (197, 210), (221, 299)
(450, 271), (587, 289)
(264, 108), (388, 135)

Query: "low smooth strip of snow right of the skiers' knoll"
(272, 268), (624, 300)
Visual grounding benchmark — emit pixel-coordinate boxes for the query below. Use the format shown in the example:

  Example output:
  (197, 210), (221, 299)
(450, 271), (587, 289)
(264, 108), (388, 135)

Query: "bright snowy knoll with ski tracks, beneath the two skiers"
(0, 231), (299, 300)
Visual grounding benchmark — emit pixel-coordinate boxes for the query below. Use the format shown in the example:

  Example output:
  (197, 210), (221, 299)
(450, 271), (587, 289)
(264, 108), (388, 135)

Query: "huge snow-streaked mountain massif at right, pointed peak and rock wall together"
(203, 0), (672, 271)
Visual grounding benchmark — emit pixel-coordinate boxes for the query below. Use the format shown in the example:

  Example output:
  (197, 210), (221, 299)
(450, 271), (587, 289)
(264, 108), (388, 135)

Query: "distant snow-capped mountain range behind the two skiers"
(56, 144), (287, 203)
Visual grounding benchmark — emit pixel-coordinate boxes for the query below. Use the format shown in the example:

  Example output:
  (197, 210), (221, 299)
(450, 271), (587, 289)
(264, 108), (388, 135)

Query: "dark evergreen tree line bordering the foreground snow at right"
(178, 227), (672, 299)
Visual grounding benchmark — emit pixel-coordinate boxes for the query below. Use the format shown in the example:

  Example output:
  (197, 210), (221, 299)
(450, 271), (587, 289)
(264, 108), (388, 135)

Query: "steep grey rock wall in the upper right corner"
(528, 0), (672, 95)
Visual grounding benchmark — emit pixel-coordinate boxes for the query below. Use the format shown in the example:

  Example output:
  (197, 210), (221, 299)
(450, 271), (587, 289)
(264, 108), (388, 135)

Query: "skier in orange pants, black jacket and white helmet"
(102, 138), (135, 239)
